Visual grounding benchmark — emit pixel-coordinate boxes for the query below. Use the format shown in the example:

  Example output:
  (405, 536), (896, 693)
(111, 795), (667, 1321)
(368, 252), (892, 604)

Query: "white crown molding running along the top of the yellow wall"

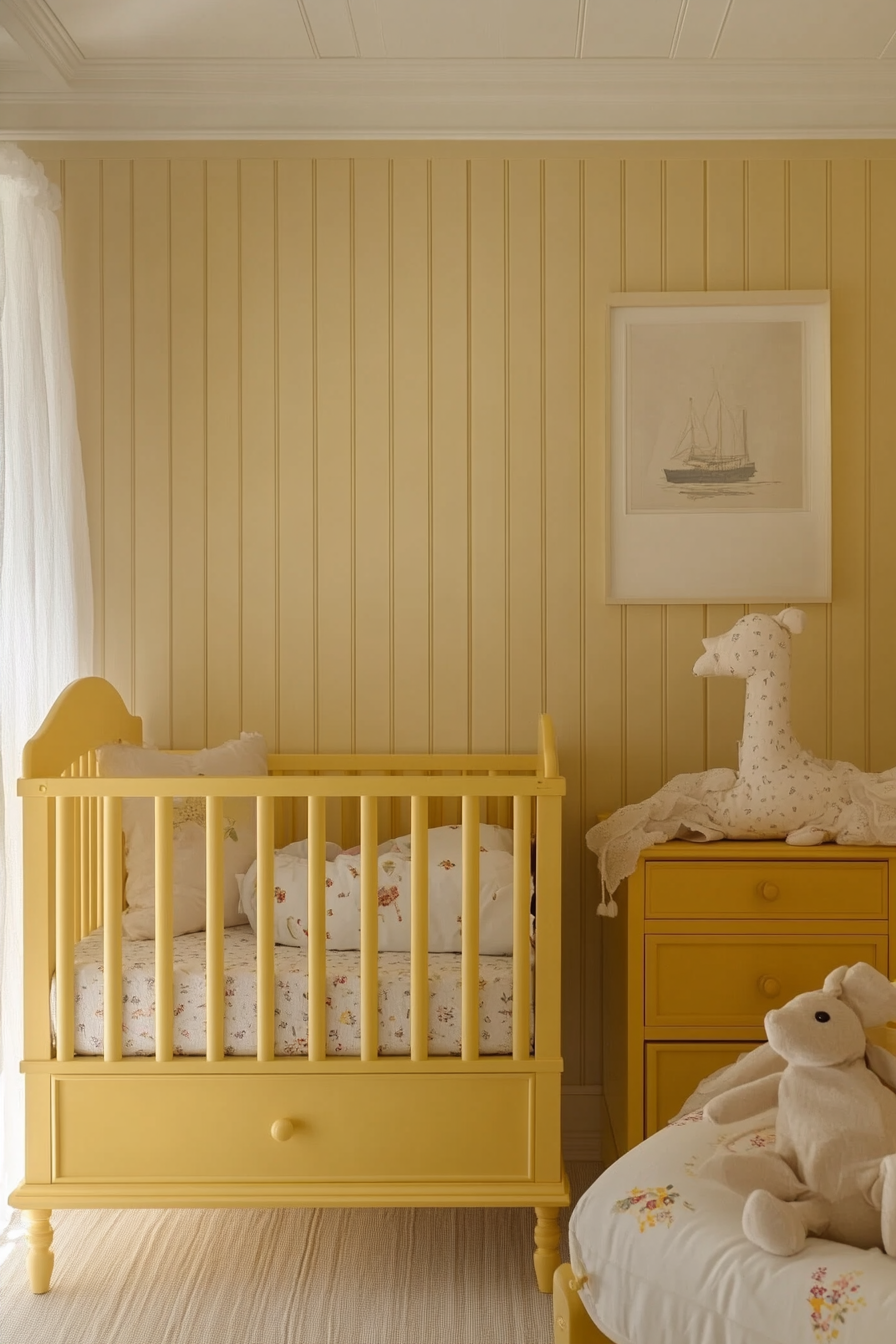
(0, 56), (896, 140)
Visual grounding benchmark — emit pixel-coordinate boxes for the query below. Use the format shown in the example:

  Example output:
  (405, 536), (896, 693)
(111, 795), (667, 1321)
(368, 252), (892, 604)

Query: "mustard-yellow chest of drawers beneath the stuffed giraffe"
(603, 840), (896, 1161)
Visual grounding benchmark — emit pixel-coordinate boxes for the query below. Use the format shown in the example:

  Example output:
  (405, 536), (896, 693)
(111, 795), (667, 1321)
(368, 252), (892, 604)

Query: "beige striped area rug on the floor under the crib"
(0, 1163), (599, 1344)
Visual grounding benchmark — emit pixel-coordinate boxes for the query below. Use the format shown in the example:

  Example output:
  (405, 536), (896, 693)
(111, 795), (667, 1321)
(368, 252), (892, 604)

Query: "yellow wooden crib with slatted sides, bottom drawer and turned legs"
(11, 677), (568, 1293)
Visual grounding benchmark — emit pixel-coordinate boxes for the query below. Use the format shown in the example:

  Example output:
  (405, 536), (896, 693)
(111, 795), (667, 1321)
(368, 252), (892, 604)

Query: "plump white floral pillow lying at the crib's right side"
(242, 825), (513, 956)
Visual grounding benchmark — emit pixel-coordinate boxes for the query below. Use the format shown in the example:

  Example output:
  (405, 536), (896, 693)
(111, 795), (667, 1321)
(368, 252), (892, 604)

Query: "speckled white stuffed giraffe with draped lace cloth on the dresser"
(586, 607), (896, 915)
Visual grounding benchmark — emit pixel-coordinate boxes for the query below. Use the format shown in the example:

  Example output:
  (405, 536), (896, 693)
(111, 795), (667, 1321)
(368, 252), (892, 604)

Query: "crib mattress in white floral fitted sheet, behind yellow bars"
(59, 925), (513, 1056)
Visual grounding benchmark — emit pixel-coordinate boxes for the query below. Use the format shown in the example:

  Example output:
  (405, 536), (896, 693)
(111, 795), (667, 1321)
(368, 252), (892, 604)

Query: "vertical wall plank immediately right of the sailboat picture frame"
(830, 159), (869, 769)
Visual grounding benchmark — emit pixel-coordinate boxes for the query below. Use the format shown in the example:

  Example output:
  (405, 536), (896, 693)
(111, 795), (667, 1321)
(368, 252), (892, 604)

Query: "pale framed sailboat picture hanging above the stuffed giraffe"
(607, 290), (830, 602)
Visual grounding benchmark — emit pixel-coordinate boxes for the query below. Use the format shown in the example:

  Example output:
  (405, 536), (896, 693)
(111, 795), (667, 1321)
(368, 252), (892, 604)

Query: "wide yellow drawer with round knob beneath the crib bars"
(54, 1074), (533, 1181)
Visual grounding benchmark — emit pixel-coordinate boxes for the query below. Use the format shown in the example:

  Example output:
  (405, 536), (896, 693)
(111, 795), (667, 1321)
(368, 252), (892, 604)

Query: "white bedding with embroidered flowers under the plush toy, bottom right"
(570, 1111), (896, 1344)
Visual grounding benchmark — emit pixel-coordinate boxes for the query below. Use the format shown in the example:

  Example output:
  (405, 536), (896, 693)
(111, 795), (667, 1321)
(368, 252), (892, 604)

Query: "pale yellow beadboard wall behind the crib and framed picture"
(30, 142), (896, 1102)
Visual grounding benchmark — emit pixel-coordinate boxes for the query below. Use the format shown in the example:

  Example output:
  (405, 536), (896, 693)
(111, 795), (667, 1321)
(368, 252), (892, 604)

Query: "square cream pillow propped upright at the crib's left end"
(97, 732), (267, 938)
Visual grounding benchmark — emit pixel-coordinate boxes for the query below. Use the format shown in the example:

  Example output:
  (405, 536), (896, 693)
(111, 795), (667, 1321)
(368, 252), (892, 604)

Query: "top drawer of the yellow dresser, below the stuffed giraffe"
(645, 859), (888, 919)
